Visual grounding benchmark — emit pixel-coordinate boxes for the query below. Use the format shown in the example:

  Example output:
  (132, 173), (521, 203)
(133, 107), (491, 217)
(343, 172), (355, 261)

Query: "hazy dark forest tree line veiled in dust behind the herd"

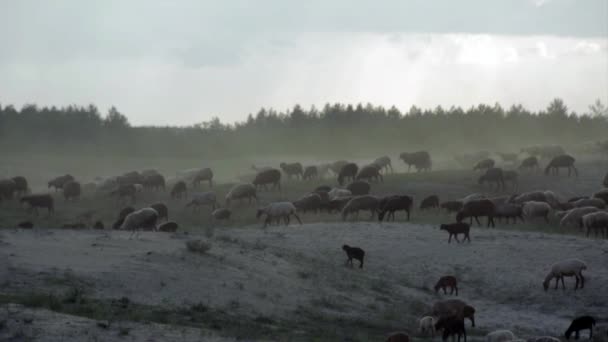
(0, 99), (608, 159)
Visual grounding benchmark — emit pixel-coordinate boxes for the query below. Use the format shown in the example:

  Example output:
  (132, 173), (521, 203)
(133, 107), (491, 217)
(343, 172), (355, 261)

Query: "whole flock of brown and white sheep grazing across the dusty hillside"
(0, 146), (608, 342)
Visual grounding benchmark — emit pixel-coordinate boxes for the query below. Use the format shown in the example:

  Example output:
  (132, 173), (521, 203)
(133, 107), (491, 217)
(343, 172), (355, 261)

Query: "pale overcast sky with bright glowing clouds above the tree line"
(0, 0), (608, 125)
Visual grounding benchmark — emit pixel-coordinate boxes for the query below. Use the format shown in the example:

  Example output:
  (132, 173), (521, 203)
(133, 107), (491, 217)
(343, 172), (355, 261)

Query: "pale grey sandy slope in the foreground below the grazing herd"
(0, 223), (608, 341)
